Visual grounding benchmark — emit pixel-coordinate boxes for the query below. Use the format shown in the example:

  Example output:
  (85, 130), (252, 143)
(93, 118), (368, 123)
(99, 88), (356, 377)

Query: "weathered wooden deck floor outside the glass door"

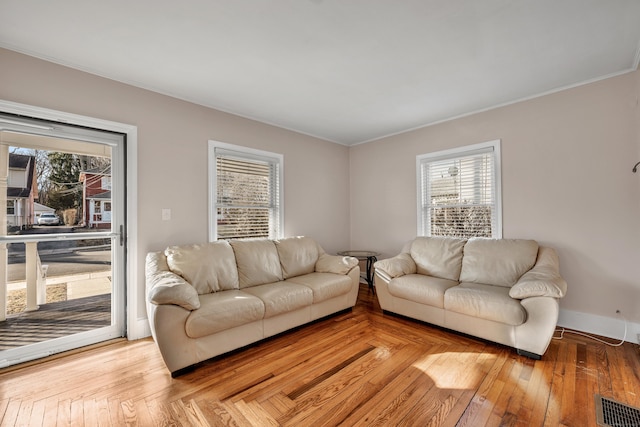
(0, 294), (111, 350)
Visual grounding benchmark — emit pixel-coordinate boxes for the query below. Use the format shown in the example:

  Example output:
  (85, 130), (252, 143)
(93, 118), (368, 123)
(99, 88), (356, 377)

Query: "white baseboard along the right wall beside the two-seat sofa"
(558, 310), (640, 344)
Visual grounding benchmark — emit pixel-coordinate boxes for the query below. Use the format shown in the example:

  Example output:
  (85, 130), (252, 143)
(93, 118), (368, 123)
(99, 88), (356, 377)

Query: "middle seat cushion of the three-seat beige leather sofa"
(243, 282), (313, 318)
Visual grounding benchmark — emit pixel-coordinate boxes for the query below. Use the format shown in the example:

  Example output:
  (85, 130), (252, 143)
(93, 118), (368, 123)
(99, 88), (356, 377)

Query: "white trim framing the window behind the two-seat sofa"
(416, 139), (502, 239)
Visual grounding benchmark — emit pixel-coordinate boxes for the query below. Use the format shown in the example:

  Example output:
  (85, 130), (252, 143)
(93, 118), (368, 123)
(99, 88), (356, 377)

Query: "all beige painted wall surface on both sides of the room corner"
(0, 49), (640, 334)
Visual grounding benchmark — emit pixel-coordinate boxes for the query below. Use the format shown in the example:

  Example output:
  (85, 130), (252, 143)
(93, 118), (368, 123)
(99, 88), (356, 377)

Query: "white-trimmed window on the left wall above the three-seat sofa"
(209, 141), (283, 241)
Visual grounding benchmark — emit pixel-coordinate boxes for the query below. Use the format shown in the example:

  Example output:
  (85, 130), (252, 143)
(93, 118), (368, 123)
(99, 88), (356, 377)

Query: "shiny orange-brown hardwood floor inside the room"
(0, 285), (640, 426)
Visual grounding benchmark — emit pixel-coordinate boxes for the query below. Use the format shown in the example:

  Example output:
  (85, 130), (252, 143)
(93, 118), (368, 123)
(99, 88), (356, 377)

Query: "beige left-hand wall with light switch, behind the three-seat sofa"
(0, 49), (349, 326)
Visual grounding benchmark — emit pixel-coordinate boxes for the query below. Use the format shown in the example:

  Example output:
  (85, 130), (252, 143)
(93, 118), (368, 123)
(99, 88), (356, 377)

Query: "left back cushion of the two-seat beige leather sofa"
(410, 237), (466, 280)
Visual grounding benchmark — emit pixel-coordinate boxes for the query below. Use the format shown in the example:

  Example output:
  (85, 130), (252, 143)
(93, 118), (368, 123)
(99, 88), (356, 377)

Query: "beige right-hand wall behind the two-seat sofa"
(350, 72), (640, 324)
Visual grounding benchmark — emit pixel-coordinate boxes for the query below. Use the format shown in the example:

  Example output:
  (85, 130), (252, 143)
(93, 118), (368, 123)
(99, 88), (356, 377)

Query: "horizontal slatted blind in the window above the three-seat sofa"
(216, 149), (280, 239)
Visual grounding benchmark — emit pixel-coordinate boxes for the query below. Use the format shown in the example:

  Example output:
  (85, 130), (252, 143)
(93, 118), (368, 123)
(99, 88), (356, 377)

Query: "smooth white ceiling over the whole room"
(0, 0), (640, 145)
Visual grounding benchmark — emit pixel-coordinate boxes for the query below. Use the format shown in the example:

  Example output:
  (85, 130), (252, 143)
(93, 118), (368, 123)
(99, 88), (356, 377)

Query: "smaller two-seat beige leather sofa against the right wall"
(375, 237), (567, 359)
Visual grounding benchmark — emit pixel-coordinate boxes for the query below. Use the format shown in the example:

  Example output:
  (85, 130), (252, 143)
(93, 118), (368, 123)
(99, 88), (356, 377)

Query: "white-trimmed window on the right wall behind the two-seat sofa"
(416, 140), (502, 238)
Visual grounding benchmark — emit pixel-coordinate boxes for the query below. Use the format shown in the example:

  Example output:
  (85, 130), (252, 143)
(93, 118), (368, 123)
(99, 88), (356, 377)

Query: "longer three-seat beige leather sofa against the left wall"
(146, 237), (360, 376)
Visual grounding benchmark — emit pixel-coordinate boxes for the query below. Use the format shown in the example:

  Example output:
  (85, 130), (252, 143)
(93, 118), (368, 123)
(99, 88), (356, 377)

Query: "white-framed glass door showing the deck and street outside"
(0, 114), (126, 367)
